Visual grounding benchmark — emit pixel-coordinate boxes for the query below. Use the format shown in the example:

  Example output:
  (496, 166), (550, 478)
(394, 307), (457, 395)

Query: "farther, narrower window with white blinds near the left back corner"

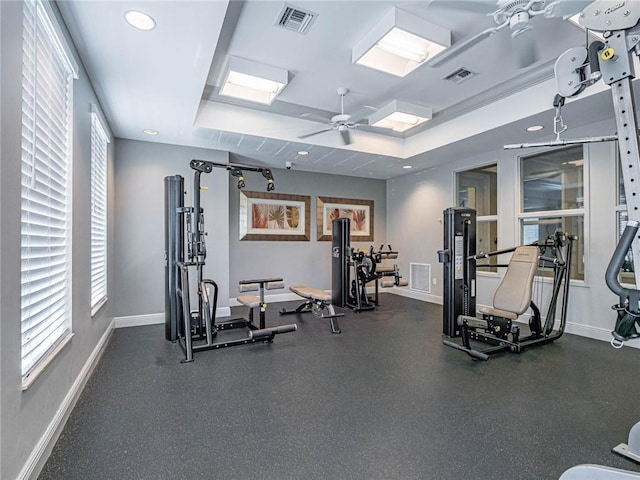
(91, 111), (109, 315)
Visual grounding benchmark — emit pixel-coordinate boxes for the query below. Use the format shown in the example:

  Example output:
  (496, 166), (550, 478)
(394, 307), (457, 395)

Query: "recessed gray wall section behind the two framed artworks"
(229, 169), (387, 297)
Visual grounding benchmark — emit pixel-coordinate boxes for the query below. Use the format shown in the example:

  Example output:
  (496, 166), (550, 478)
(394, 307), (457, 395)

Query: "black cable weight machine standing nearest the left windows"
(164, 160), (297, 362)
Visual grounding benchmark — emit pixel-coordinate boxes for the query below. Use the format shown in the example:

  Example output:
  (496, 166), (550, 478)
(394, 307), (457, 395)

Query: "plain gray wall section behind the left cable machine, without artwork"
(114, 139), (229, 317)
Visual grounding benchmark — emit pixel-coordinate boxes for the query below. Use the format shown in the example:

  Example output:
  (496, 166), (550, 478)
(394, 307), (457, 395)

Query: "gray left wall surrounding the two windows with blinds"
(0, 2), (114, 479)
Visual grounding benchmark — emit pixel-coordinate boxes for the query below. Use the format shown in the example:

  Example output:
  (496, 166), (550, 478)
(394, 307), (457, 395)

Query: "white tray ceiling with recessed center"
(58, 0), (613, 179)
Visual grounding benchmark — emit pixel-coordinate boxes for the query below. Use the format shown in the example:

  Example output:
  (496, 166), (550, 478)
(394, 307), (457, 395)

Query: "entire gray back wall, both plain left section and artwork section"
(114, 144), (387, 317)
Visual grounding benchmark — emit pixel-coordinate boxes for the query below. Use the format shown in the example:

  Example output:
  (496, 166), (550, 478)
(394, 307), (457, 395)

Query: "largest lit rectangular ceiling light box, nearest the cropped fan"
(351, 7), (451, 77)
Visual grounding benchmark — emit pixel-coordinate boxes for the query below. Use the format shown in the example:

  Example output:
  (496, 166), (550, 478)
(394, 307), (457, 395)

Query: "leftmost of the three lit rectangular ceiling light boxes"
(219, 57), (289, 105)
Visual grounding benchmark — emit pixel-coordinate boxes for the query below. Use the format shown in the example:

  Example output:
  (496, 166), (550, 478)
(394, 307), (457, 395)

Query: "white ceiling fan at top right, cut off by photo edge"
(430, 0), (593, 68)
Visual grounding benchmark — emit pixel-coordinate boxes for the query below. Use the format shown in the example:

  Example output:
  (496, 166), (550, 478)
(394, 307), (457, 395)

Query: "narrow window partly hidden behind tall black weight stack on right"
(456, 163), (498, 272)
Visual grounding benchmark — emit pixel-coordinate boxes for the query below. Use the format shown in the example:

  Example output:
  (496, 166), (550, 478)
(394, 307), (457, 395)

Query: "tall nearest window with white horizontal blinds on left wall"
(21, 0), (77, 383)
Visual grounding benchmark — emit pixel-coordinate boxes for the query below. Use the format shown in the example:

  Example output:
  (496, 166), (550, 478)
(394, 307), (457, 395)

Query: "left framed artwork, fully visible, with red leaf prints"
(239, 191), (311, 242)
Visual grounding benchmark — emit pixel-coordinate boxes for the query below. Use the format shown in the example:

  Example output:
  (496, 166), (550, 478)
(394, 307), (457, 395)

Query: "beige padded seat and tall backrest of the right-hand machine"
(479, 245), (540, 320)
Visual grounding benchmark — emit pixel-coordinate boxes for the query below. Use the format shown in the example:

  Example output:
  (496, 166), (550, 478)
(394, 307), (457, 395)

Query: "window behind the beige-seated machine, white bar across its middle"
(519, 145), (585, 280)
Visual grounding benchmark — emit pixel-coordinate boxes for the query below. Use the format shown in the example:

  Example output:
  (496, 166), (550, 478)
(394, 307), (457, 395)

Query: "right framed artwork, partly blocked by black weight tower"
(316, 197), (373, 242)
